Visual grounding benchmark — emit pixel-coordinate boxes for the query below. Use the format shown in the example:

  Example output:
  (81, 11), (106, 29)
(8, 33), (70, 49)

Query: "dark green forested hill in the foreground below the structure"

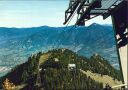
(1, 49), (121, 90)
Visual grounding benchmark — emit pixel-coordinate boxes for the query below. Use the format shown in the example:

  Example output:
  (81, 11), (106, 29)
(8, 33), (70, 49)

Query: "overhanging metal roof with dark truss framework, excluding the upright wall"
(64, 0), (124, 25)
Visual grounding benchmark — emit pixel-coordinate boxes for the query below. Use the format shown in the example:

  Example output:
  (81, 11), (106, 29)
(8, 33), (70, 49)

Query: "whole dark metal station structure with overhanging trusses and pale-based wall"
(64, 0), (128, 88)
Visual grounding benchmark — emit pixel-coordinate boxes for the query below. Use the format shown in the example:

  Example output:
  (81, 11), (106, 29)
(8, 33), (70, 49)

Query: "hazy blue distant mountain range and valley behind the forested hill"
(0, 23), (118, 74)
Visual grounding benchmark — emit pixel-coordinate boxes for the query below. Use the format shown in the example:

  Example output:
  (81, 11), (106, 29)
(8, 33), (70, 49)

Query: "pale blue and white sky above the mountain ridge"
(0, 0), (112, 28)
